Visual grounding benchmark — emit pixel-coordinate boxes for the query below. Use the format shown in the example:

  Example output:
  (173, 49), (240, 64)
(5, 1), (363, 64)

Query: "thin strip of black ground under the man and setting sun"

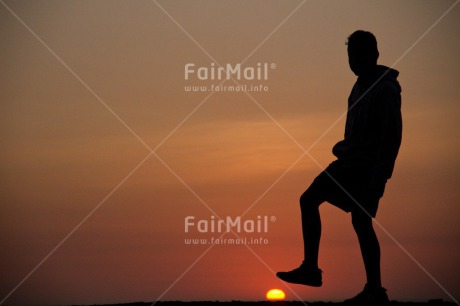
(74, 299), (457, 306)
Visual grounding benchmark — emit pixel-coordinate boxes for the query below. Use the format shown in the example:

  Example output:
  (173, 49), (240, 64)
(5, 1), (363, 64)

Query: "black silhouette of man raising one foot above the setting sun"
(276, 30), (402, 305)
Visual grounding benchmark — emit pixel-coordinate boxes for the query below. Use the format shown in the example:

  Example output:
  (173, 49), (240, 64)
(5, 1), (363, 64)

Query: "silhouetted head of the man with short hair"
(346, 30), (379, 76)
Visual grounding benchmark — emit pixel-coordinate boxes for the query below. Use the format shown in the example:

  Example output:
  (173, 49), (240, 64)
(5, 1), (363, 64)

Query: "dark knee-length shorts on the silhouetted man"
(304, 160), (387, 218)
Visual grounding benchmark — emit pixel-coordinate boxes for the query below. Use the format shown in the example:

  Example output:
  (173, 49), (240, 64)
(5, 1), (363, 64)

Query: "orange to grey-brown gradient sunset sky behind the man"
(0, 0), (460, 305)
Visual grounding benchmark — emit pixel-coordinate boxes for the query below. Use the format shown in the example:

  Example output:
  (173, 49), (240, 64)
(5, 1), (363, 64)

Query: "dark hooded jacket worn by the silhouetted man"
(332, 65), (402, 180)
